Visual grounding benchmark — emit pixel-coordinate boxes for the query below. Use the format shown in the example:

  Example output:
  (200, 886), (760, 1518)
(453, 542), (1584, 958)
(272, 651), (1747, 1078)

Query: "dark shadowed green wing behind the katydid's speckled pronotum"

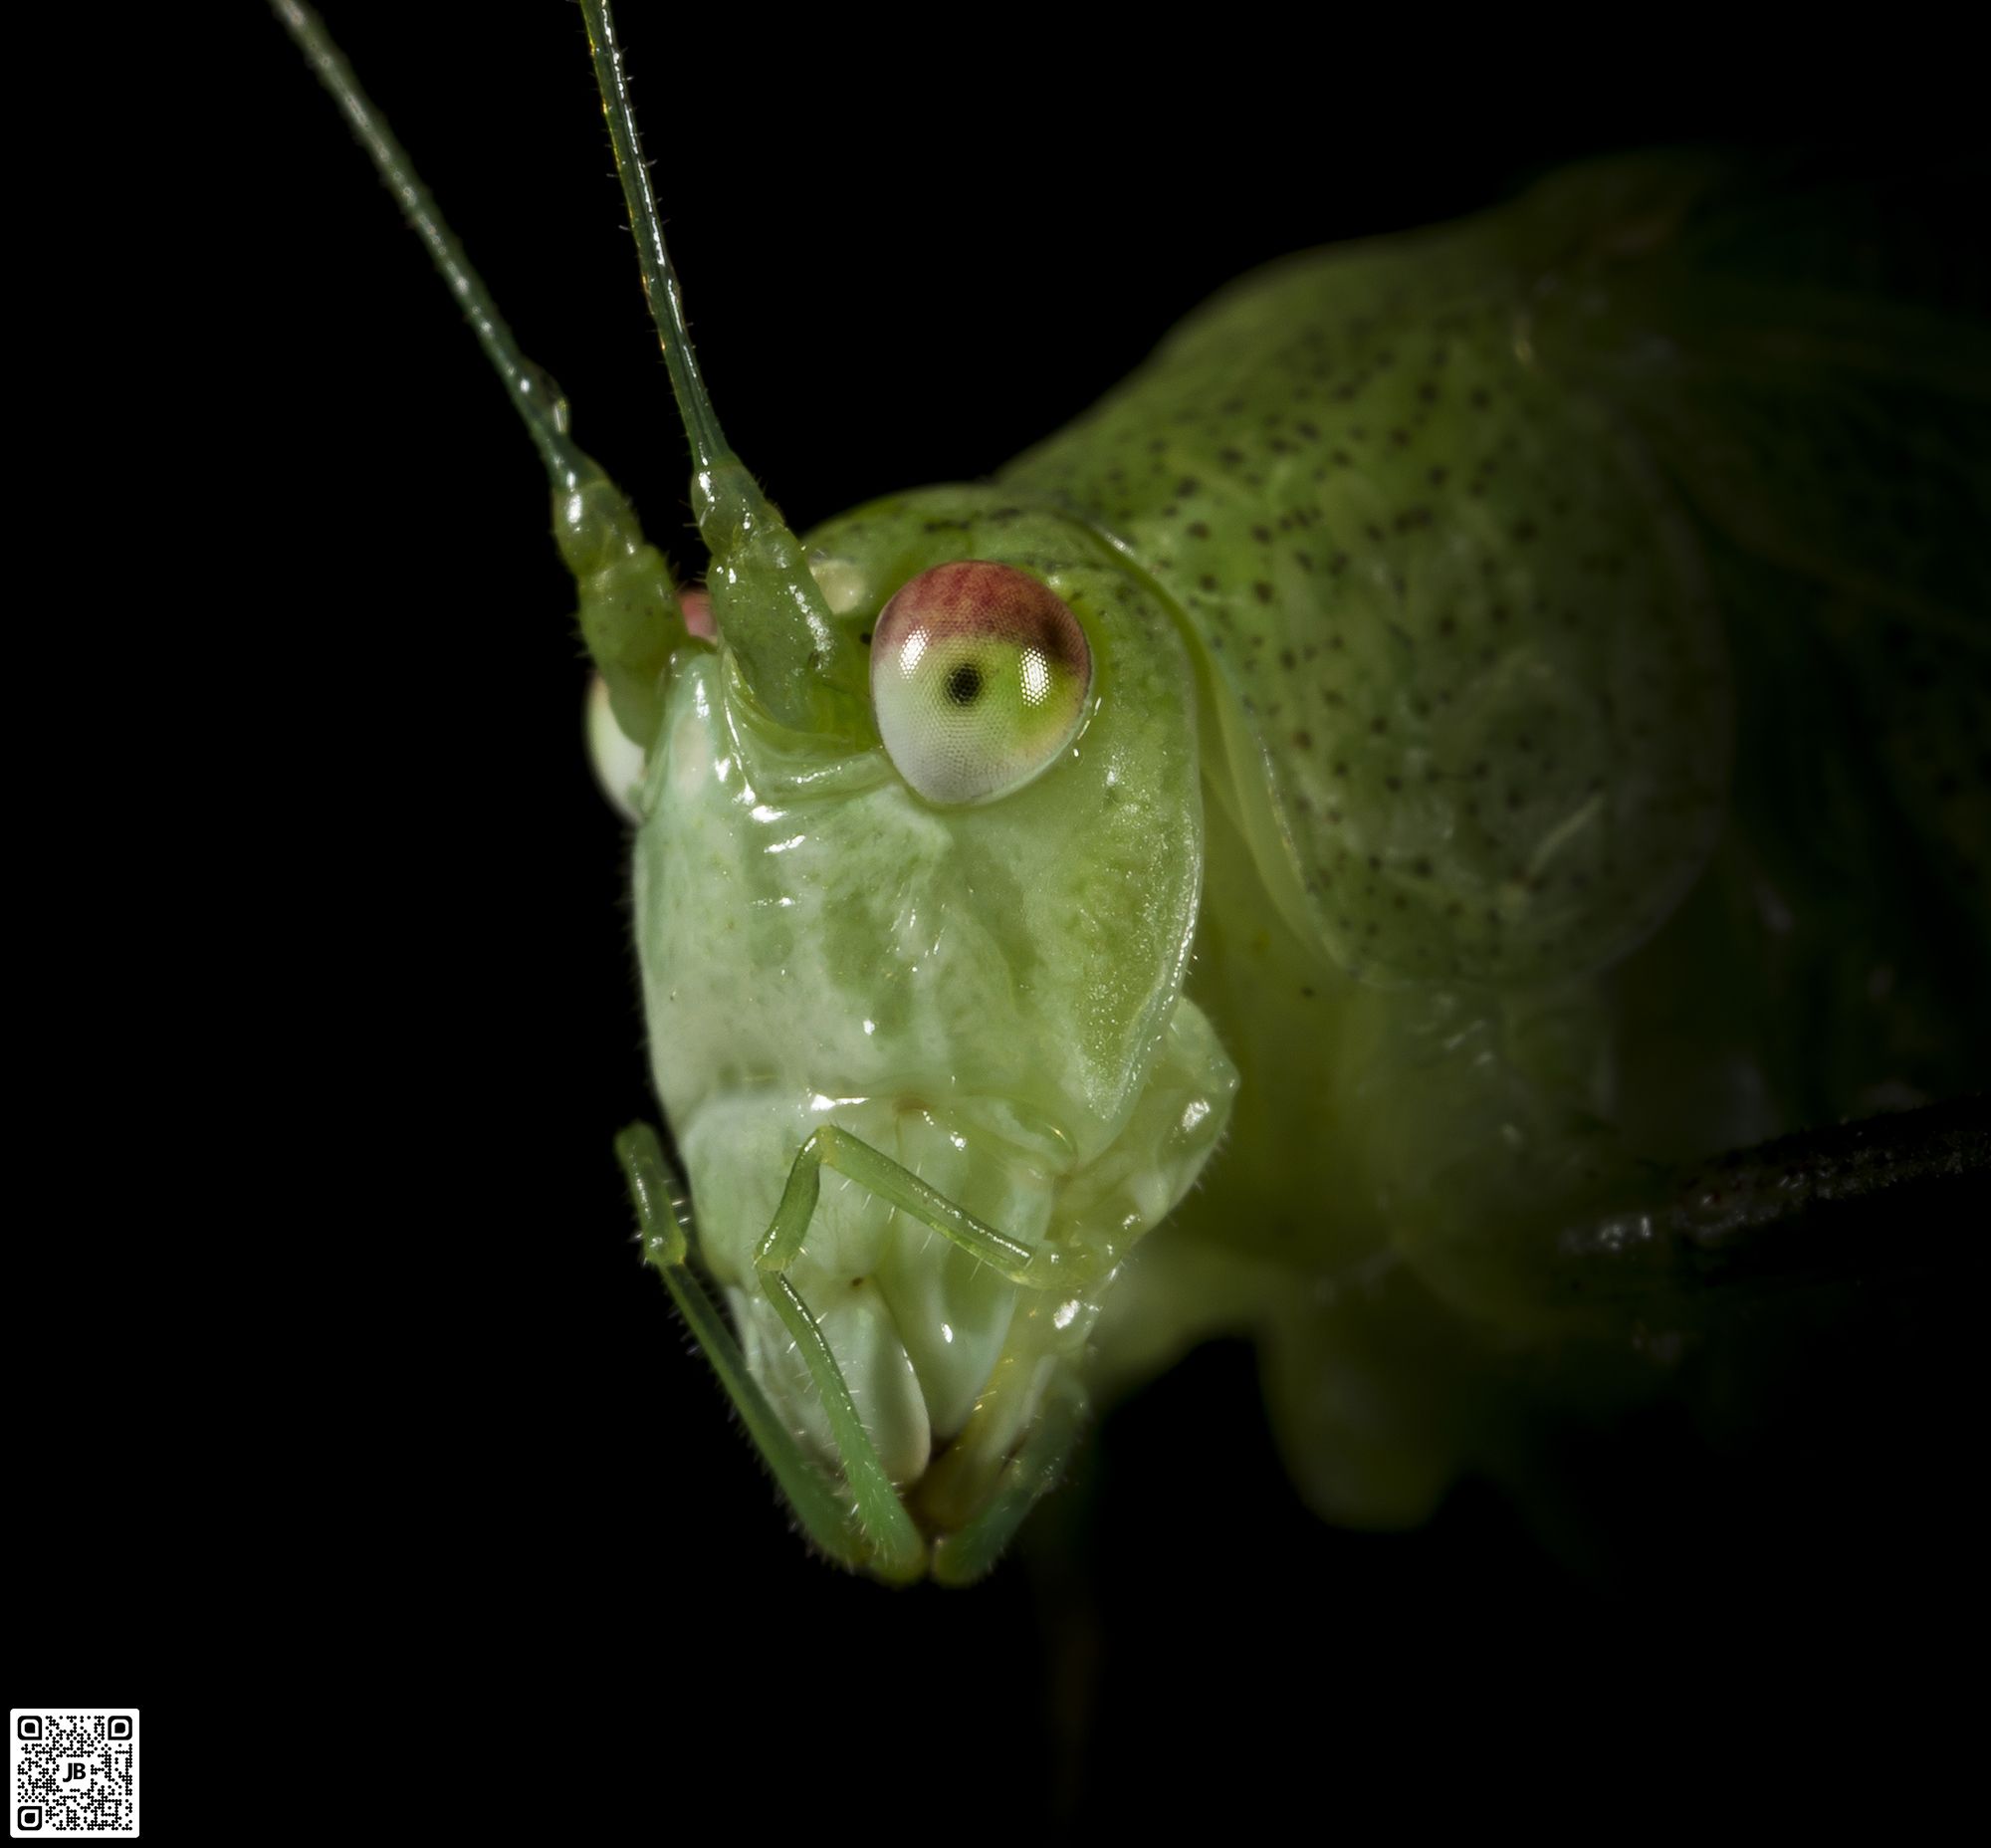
(1543, 159), (1991, 980)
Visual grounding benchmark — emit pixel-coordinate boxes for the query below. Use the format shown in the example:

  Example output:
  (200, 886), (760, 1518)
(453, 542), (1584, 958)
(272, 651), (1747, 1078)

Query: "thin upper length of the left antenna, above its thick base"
(271, 0), (601, 492)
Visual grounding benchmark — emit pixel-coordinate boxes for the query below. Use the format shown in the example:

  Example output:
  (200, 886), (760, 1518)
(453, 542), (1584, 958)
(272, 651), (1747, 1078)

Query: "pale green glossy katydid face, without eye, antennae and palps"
(635, 490), (1234, 1484)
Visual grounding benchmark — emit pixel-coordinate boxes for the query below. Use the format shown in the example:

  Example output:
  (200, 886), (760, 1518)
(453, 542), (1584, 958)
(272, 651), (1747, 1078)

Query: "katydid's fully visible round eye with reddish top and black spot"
(872, 560), (1093, 803)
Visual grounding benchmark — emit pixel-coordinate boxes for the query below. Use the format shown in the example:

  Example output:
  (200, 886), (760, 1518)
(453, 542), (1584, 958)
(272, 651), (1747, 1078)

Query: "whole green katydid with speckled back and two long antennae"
(279, 0), (1991, 1581)
